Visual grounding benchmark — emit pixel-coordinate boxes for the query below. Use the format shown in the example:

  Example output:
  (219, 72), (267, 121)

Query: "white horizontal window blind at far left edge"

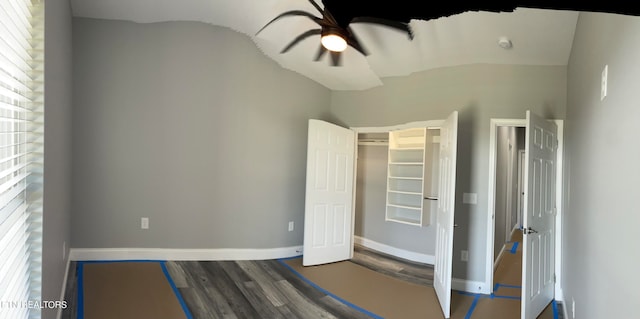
(0, 0), (44, 319)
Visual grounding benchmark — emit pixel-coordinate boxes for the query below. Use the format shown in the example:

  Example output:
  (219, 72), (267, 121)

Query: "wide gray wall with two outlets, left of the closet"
(72, 18), (330, 248)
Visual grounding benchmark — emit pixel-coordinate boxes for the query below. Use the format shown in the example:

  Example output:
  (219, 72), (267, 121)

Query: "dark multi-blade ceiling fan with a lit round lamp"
(256, 0), (413, 66)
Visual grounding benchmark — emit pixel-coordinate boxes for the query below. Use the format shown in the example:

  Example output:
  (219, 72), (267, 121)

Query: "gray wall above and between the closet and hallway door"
(331, 64), (567, 281)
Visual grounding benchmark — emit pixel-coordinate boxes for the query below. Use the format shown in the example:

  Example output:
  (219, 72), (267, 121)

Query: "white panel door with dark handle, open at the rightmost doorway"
(521, 111), (558, 319)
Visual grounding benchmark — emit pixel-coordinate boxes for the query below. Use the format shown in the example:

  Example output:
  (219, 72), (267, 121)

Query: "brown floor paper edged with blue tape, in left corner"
(82, 262), (187, 319)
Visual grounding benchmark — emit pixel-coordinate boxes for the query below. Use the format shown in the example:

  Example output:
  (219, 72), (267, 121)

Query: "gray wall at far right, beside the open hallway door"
(562, 13), (640, 319)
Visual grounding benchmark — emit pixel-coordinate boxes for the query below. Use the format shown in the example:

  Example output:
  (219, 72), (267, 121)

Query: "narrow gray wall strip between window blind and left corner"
(42, 0), (72, 318)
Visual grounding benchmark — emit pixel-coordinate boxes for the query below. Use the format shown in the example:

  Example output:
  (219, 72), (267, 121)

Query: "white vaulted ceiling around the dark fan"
(71, 0), (578, 90)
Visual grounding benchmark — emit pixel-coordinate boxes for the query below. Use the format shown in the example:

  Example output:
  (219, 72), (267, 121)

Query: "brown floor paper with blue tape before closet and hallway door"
(285, 242), (554, 319)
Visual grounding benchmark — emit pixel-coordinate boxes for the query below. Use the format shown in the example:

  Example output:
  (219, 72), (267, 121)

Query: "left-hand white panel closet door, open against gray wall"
(302, 119), (356, 266)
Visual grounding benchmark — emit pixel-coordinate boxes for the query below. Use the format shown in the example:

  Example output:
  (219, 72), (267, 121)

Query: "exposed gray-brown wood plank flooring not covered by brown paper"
(62, 246), (564, 319)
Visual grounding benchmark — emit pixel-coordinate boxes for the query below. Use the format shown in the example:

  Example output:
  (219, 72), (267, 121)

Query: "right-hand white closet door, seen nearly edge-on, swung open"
(433, 112), (458, 318)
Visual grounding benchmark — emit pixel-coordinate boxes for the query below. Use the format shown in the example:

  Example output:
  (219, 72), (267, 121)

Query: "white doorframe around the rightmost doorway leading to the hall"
(485, 118), (564, 301)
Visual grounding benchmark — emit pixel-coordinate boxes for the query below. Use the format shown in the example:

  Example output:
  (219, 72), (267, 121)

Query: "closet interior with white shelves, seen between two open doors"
(354, 126), (440, 265)
